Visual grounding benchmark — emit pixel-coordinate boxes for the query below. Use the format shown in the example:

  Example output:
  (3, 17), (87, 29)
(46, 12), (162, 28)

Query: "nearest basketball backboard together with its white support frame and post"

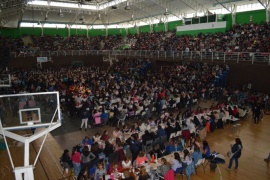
(0, 92), (61, 180)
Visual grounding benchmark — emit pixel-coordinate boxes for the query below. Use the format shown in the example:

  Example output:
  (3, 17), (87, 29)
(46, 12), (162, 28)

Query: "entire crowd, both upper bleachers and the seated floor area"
(0, 21), (270, 180)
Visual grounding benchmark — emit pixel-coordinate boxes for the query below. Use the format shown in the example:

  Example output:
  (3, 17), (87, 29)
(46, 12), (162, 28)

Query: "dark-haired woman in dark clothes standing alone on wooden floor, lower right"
(226, 138), (243, 171)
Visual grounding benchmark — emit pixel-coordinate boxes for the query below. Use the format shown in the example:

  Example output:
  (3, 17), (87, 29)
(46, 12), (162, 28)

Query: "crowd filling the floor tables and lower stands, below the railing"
(1, 55), (269, 177)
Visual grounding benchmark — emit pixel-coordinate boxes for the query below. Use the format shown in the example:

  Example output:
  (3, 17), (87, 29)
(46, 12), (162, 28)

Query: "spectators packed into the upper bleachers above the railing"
(1, 23), (270, 53)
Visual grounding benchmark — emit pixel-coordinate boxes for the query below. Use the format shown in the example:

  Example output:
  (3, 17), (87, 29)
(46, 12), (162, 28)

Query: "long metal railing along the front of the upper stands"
(11, 50), (270, 65)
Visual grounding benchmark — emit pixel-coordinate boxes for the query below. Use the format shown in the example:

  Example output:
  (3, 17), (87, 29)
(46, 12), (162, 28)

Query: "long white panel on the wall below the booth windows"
(177, 21), (226, 32)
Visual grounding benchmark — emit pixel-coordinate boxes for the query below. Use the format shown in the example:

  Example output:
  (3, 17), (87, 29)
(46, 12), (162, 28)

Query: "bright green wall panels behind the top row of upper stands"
(0, 10), (266, 38)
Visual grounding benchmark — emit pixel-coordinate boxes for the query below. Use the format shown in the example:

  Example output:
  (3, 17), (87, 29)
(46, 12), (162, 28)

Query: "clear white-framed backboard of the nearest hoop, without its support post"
(0, 92), (60, 130)
